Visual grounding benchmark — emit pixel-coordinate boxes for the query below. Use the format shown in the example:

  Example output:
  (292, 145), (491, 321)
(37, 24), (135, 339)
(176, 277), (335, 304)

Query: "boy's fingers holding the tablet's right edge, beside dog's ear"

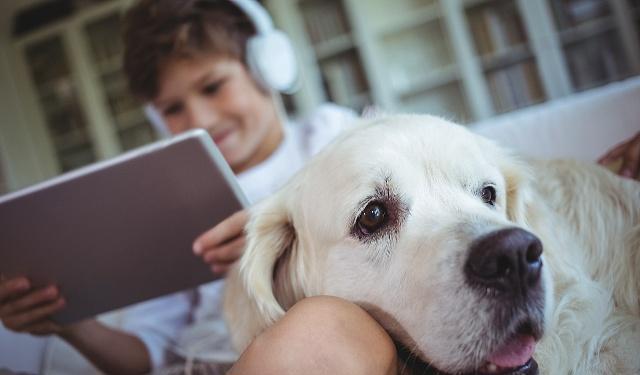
(193, 210), (249, 274)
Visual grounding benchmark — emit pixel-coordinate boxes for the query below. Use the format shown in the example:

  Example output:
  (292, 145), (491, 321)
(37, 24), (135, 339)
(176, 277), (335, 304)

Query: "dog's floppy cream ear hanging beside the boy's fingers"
(240, 191), (304, 325)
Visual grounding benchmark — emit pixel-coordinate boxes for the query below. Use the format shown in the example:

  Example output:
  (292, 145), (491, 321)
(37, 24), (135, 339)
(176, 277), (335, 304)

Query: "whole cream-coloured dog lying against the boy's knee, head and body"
(225, 116), (640, 374)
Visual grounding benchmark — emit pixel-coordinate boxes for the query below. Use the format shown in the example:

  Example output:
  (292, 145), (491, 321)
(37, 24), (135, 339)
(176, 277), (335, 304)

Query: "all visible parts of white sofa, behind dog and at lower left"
(0, 77), (640, 374)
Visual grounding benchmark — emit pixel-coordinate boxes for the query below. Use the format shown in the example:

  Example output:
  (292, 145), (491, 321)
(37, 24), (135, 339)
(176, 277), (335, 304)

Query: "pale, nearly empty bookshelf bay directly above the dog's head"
(357, 0), (470, 121)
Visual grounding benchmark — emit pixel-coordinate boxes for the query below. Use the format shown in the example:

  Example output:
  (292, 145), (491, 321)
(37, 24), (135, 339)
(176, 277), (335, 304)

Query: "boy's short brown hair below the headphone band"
(124, 0), (256, 101)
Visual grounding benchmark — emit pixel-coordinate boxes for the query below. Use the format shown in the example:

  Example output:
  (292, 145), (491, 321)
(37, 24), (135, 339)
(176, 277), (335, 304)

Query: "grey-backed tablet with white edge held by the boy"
(0, 129), (248, 324)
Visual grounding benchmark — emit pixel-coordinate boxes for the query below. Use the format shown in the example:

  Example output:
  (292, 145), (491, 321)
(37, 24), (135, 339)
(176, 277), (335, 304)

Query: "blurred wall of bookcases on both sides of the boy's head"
(0, 0), (640, 194)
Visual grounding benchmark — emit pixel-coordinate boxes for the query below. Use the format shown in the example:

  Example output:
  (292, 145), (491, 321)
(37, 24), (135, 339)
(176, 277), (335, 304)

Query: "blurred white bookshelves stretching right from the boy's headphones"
(265, 0), (640, 122)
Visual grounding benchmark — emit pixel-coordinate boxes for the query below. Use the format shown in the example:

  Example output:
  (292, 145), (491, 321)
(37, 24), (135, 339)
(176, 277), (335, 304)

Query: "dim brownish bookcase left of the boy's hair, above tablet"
(13, 0), (155, 176)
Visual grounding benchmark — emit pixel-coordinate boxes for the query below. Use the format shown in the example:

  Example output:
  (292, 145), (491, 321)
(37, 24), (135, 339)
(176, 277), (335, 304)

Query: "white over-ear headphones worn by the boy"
(144, 0), (299, 137)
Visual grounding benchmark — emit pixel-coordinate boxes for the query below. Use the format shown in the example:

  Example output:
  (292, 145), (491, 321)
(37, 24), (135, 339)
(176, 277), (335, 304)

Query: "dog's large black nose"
(465, 228), (542, 296)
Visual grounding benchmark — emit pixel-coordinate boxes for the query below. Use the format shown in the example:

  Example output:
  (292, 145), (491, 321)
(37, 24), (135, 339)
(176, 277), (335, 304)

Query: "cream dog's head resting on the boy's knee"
(232, 116), (550, 373)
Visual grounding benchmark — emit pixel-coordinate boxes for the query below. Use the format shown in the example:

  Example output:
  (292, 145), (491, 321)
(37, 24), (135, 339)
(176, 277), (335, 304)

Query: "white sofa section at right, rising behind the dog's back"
(470, 77), (640, 161)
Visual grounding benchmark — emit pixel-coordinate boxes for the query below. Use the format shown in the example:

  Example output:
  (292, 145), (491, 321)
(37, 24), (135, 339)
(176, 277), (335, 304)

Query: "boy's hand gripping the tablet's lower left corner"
(0, 276), (65, 336)
